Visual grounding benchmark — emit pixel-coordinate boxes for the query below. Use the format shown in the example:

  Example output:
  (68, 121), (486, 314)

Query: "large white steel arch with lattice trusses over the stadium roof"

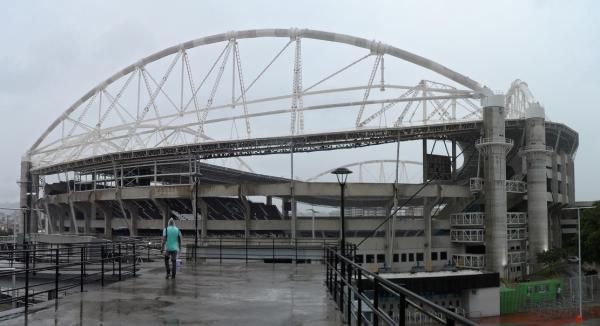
(27, 29), (536, 167)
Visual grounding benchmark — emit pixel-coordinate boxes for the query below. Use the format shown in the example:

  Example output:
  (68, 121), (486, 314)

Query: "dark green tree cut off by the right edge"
(581, 202), (600, 263)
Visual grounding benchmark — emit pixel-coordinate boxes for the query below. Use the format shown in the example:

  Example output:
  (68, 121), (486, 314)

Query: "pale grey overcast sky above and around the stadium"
(0, 0), (600, 202)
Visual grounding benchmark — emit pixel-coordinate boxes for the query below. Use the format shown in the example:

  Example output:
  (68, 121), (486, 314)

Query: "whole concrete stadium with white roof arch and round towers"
(20, 29), (578, 290)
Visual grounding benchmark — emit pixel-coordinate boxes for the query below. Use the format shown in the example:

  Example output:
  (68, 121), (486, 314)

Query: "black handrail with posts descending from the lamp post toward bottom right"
(325, 247), (477, 326)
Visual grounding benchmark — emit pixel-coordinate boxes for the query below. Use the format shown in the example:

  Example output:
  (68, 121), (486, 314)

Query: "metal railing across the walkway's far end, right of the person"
(185, 237), (338, 263)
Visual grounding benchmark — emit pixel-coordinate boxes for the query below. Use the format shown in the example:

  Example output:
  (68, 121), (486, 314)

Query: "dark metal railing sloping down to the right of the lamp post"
(325, 247), (477, 326)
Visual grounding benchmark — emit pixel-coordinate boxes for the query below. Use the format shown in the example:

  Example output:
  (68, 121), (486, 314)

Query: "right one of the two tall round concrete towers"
(523, 103), (549, 264)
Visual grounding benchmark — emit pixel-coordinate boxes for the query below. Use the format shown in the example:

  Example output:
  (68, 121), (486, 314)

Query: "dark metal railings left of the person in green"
(0, 241), (145, 313)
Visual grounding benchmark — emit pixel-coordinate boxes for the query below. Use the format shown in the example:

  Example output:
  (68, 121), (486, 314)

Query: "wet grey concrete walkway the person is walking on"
(0, 262), (341, 326)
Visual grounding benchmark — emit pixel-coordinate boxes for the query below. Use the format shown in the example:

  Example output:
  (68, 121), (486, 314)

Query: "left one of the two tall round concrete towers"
(477, 95), (510, 278)
